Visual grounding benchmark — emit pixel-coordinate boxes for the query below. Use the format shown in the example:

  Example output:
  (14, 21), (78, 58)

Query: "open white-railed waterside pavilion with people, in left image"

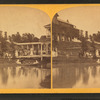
(14, 42), (51, 61)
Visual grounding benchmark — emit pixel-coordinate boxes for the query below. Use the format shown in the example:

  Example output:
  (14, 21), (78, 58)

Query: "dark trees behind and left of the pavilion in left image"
(0, 32), (46, 57)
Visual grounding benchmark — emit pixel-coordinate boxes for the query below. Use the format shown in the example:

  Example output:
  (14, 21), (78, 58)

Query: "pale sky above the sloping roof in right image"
(58, 6), (100, 35)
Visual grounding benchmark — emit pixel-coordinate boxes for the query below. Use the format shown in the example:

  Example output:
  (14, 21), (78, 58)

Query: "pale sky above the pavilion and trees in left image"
(0, 6), (51, 37)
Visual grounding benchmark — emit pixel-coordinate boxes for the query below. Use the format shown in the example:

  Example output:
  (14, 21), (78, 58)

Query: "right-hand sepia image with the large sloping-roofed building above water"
(52, 6), (100, 88)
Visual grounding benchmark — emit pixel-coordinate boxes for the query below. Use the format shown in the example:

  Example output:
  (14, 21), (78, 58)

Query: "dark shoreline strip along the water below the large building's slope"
(52, 57), (100, 68)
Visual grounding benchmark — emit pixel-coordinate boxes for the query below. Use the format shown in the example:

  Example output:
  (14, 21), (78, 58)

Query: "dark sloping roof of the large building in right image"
(52, 13), (79, 36)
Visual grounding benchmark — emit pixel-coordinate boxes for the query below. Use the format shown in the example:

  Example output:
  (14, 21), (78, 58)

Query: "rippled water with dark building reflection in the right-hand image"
(53, 63), (100, 88)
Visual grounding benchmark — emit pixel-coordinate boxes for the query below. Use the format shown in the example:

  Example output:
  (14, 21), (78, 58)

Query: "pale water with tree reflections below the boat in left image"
(0, 65), (51, 89)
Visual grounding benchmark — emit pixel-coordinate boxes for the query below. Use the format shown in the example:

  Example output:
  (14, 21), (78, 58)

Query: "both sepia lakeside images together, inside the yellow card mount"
(0, 6), (100, 89)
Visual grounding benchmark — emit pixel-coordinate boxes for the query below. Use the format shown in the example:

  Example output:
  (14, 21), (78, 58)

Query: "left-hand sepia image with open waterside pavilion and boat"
(0, 6), (51, 89)
